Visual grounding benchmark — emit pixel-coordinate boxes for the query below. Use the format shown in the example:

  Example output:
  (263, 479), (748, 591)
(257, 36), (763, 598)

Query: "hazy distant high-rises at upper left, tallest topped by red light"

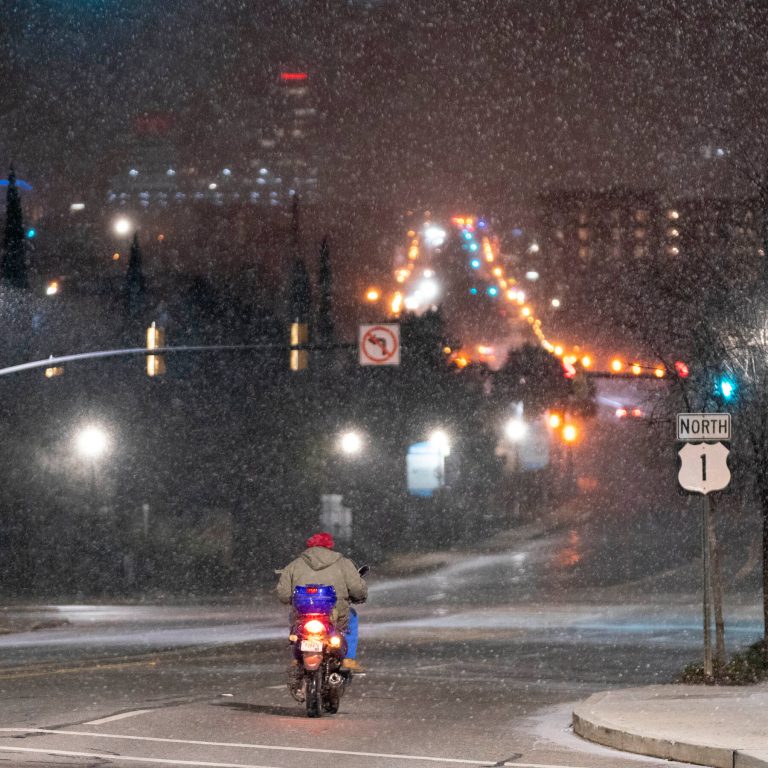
(107, 71), (320, 213)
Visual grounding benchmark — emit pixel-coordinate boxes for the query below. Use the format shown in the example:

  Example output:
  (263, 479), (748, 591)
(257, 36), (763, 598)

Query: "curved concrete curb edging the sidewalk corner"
(573, 692), (768, 768)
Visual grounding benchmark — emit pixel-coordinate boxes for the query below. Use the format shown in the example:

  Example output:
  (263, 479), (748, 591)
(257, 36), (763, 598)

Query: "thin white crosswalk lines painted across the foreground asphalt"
(0, 728), (608, 768)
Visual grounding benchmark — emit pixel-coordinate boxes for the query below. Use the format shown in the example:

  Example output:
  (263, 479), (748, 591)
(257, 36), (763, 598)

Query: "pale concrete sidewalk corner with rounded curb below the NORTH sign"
(573, 683), (768, 768)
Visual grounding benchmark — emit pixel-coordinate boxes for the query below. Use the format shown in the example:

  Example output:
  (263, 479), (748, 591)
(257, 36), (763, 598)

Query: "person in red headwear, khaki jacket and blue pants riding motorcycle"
(277, 531), (368, 672)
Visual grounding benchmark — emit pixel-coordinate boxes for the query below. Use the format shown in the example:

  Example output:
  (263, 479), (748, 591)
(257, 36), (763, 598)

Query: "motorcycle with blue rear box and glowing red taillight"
(288, 566), (368, 717)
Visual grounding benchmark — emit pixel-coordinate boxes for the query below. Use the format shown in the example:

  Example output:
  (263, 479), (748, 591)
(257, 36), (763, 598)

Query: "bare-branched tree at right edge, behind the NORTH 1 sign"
(606, 242), (768, 653)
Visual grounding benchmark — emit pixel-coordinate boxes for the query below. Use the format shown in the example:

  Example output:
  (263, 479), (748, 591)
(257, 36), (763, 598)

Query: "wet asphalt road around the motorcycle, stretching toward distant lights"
(0, 400), (761, 768)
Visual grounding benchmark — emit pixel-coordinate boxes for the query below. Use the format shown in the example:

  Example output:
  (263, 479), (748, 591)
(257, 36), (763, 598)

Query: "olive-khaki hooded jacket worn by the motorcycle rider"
(277, 547), (368, 628)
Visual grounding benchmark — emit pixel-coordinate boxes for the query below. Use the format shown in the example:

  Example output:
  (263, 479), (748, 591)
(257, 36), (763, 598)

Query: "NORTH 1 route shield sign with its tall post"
(677, 413), (731, 677)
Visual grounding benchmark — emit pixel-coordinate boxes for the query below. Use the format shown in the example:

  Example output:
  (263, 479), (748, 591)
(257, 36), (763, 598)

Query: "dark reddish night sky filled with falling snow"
(0, 0), (768, 210)
